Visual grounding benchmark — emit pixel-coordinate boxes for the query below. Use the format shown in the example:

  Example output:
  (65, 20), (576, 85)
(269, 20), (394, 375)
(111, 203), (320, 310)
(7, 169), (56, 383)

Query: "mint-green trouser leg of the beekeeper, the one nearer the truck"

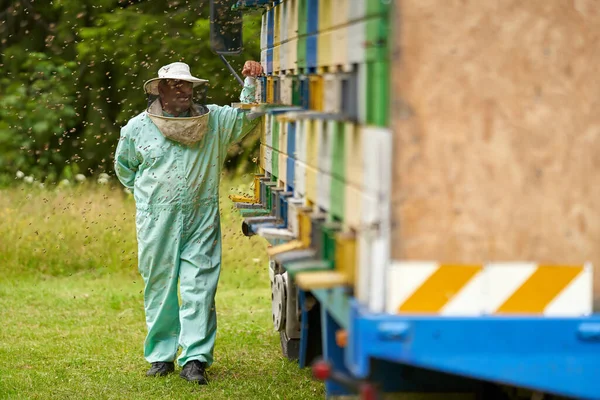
(177, 203), (221, 367)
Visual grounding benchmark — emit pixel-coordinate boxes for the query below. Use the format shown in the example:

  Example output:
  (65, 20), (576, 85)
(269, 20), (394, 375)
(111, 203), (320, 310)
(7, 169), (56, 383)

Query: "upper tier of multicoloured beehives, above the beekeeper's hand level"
(257, 0), (390, 126)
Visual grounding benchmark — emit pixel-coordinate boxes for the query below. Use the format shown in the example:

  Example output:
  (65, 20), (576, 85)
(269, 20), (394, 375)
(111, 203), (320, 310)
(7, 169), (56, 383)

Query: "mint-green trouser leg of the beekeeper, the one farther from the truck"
(136, 209), (181, 363)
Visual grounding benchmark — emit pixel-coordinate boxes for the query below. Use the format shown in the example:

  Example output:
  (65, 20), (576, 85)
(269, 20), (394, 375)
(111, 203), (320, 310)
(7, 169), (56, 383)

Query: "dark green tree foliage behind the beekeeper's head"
(0, 0), (260, 181)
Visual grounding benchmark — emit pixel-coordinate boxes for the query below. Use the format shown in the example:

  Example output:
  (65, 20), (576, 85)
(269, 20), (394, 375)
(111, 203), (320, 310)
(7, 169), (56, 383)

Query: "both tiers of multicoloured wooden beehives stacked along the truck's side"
(232, 0), (392, 309)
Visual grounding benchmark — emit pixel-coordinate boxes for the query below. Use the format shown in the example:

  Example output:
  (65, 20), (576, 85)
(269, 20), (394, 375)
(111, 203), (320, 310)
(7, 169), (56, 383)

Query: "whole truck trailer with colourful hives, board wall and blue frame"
(227, 0), (600, 398)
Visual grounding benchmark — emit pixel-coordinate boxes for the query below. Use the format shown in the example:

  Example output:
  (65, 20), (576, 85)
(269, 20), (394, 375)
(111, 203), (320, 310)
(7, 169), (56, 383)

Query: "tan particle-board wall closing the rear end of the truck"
(391, 0), (600, 293)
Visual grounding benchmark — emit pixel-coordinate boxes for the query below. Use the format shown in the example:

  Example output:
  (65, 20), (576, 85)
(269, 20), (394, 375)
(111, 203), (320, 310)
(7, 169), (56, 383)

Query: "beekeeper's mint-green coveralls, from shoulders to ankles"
(115, 86), (260, 366)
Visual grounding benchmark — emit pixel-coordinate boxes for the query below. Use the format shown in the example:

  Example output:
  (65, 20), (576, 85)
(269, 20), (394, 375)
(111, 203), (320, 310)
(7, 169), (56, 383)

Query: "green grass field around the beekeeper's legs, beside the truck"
(0, 180), (324, 399)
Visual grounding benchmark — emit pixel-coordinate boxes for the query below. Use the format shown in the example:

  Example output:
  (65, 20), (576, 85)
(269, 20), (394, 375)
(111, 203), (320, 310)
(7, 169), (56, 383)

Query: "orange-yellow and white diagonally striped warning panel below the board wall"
(386, 262), (593, 316)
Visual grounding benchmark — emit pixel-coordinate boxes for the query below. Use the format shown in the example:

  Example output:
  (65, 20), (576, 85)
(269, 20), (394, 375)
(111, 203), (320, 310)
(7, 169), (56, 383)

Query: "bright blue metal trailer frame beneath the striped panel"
(311, 289), (600, 399)
